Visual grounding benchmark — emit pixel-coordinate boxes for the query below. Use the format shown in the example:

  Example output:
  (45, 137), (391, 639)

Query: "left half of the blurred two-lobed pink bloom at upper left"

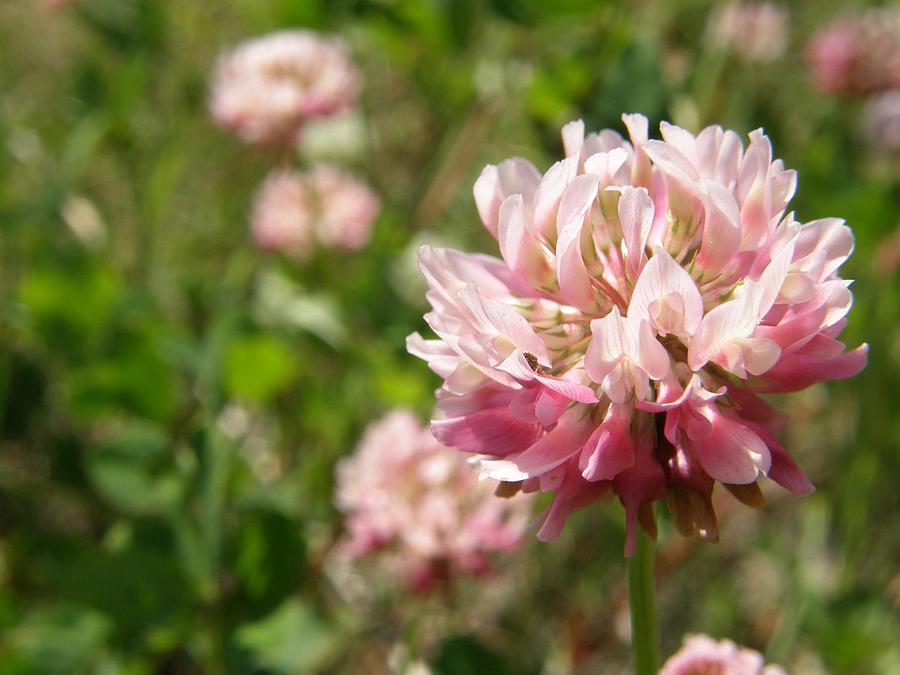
(250, 169), (315, 260)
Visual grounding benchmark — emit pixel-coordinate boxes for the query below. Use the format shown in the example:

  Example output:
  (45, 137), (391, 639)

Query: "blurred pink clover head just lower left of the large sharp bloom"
(336, 410), (530, 590)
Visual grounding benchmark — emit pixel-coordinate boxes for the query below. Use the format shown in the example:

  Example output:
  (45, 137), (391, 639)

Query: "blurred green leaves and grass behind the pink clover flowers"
(0, 0), (900, 675)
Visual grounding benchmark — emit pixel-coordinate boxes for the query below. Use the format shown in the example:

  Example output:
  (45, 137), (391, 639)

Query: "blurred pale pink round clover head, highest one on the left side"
(210, 30), (360, 145)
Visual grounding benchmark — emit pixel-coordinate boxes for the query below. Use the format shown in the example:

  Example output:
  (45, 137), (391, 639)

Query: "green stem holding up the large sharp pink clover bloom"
(628, 528), (659, 675)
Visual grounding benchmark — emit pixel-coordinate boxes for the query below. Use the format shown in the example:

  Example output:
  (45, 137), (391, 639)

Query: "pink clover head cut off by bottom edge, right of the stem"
(659, 635), (786, 675)
